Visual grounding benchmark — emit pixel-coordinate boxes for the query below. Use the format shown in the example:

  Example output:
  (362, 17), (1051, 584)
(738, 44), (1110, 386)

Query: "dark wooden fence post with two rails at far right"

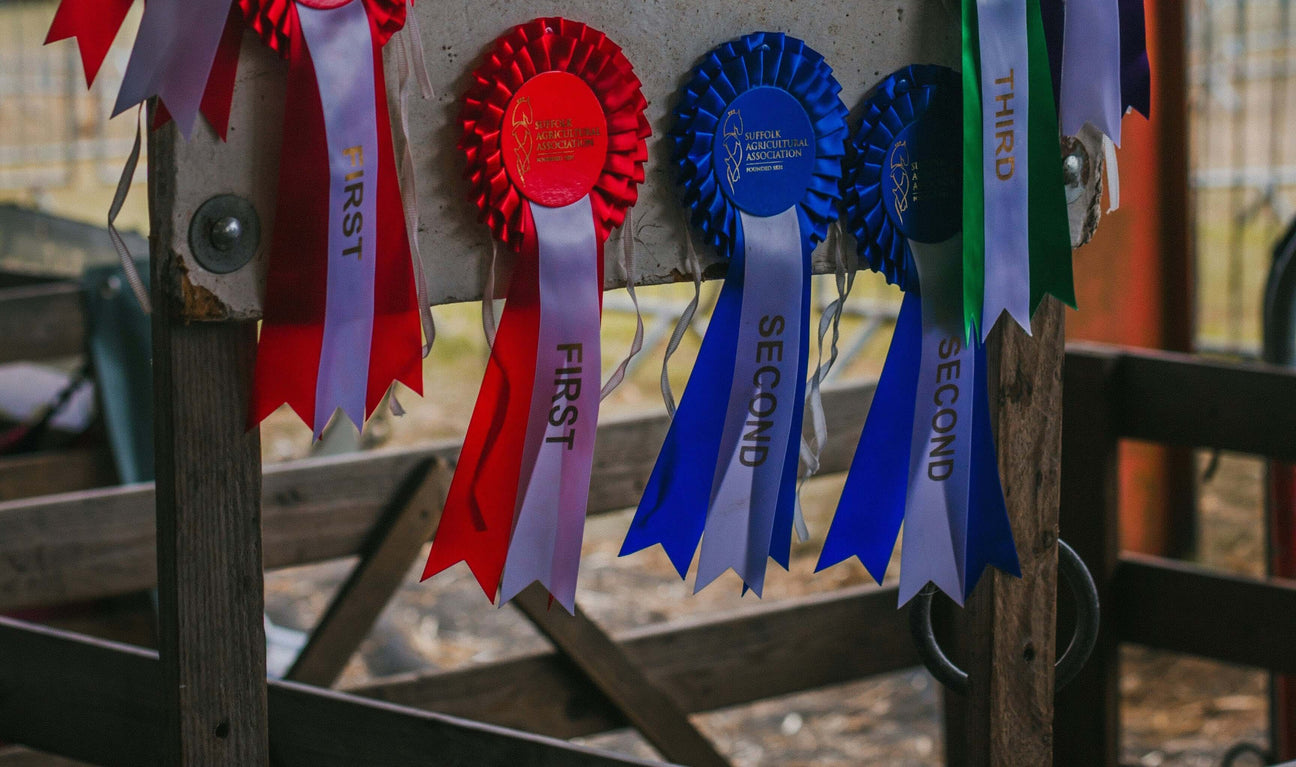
(1054, 345), (1296, 767)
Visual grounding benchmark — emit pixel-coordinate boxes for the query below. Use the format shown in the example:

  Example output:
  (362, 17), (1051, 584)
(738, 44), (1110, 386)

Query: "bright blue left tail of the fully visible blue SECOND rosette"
(619, 248), (743, 578)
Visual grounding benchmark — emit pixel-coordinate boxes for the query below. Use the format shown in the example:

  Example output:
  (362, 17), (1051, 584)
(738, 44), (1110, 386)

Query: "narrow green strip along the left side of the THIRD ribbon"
(963, 0), (979, 343)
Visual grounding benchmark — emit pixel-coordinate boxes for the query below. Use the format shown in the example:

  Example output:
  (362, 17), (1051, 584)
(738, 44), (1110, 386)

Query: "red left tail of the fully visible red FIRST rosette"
(422, 206), (540, 602)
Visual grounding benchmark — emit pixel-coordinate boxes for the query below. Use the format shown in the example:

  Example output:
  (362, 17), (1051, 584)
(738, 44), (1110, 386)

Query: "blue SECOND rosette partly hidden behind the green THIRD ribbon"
(818, 66), (1020, 604)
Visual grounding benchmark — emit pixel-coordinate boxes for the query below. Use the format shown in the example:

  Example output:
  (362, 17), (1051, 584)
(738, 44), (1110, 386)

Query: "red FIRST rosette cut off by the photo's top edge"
(240, 0), (422, 438)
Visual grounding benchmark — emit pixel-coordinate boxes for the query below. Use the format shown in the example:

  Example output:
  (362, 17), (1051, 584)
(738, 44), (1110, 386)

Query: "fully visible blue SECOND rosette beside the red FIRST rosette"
(621, 32), (848, 595)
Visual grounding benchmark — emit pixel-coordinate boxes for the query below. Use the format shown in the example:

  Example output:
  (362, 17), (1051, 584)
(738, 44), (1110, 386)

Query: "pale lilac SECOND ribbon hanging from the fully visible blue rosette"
(695, 206), (805, 596)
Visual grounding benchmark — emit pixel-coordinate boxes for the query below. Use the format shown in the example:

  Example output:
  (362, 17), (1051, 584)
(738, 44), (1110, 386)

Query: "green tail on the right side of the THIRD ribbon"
(1026, 0), (1076, 315)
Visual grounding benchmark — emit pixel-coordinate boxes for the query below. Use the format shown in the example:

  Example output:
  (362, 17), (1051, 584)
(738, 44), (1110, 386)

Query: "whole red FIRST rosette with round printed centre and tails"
(424, 18), (651, 612)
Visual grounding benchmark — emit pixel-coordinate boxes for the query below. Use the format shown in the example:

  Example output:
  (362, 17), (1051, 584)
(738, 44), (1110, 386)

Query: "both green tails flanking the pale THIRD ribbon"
(963, 0), (1076, 339)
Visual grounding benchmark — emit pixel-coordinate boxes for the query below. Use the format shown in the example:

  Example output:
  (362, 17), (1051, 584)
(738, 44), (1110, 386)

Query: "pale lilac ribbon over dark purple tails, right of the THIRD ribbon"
(1059, 0), (1121, 146)
